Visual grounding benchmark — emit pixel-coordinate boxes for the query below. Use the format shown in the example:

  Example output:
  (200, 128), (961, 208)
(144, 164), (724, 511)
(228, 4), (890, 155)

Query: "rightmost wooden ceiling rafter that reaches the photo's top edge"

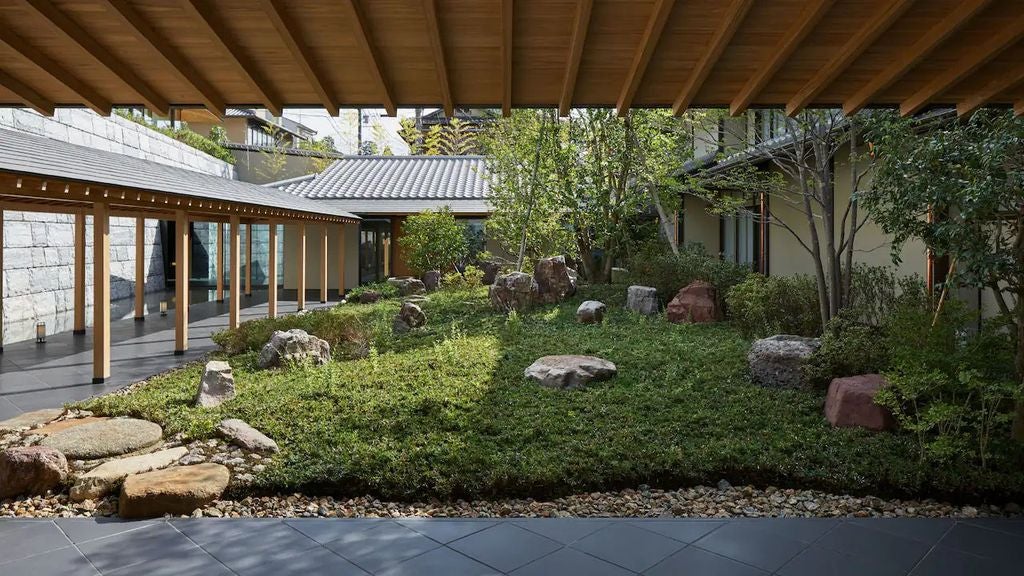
(843, 0), (991, 116)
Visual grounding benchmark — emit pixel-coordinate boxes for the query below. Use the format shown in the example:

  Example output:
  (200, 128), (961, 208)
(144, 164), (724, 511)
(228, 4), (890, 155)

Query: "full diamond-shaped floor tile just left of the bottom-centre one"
(326, 522), (440, 573)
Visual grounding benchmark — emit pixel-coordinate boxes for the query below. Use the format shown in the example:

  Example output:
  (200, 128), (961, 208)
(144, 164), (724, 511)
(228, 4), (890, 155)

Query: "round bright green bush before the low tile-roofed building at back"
(398, 206), (468, 275)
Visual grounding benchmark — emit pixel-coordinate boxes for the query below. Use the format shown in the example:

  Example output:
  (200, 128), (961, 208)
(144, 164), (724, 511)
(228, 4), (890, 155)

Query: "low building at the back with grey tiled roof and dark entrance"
(267, 156), (490, 284)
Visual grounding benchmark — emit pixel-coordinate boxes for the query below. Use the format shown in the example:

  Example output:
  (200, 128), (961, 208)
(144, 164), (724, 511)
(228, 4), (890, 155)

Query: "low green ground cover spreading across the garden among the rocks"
(83, 286), (1024, 499)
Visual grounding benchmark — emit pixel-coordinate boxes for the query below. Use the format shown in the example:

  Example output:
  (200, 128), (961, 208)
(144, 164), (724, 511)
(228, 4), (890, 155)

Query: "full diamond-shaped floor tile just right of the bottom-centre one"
(572, 523), (686, 572)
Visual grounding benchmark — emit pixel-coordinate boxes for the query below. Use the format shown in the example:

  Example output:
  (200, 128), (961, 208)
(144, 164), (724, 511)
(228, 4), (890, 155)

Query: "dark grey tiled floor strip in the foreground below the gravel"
(0, 519), (1024, 576)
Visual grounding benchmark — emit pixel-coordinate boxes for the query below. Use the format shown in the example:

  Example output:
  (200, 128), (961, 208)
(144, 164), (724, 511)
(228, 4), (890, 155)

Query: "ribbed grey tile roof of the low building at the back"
(276, 156), (489, 207)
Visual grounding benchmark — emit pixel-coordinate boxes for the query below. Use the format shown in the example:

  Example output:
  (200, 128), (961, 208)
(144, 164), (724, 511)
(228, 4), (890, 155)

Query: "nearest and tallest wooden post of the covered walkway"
(92, 202), (111, 384)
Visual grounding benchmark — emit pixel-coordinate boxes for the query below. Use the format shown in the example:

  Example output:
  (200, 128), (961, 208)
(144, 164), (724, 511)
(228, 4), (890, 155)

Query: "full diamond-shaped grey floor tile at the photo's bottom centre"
(449, 523), (561, 572)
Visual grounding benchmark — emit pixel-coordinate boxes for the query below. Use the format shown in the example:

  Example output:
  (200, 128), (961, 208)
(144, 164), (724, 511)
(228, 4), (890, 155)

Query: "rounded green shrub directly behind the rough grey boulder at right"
(725, 274), (821, 338)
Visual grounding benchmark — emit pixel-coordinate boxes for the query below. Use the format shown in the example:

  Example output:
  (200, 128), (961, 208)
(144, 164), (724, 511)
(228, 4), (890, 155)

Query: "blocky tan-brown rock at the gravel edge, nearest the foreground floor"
(118, 463), (230, 518)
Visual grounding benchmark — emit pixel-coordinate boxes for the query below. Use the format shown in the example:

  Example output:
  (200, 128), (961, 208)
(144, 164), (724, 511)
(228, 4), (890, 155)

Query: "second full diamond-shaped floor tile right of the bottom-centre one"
(693, 522), (805, 572)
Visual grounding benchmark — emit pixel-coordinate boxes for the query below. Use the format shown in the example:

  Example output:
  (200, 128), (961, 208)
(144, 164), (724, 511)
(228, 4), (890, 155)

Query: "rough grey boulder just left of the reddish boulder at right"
(746, 334), (821, 388)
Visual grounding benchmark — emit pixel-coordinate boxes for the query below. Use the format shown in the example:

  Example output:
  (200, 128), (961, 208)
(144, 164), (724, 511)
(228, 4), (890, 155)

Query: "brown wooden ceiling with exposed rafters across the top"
(0, 0), (1024, 115)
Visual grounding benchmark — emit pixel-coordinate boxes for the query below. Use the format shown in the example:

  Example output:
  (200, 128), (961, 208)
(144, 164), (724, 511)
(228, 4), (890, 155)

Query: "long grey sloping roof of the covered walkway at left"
(0, 129), (358, 219)
